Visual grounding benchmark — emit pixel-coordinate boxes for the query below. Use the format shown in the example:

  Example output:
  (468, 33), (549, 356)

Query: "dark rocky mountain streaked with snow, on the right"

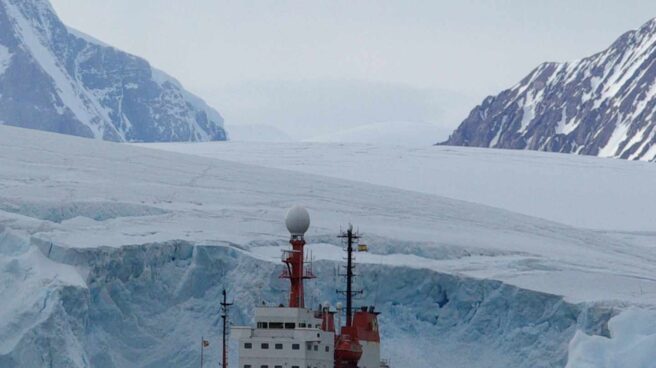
(442, 19), (656, 161)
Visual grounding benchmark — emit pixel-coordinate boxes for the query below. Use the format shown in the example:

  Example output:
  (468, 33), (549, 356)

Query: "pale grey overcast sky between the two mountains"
(51, 0), (656, 136)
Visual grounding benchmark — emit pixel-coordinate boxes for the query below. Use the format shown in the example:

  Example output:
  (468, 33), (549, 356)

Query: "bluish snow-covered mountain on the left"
(0, 0), (226, 142)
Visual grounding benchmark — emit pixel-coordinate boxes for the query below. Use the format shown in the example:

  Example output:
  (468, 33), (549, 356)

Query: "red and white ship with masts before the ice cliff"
(231, 206), (389, 368)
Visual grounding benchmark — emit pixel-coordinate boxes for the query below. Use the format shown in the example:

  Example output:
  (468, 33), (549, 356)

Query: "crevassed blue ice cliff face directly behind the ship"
(0, 237), (612, 368)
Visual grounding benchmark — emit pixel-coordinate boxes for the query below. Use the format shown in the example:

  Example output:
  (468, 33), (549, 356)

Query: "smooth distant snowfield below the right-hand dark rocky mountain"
(138, 142), (656, 231)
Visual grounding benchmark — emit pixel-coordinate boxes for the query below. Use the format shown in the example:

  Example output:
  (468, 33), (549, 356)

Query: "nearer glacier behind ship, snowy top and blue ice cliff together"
(0, 127), (656, 368)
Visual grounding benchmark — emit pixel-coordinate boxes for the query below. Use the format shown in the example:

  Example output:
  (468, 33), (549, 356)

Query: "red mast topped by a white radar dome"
(280, 206), (314, 308)
